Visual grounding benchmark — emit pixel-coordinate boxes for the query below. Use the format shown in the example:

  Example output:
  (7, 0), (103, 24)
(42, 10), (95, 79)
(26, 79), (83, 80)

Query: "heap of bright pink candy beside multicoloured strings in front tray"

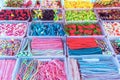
(33, 60), (67, 80)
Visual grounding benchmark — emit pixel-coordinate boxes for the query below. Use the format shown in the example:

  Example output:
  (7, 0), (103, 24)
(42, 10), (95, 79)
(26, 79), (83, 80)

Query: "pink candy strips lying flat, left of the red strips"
(31, 38), (63, 50)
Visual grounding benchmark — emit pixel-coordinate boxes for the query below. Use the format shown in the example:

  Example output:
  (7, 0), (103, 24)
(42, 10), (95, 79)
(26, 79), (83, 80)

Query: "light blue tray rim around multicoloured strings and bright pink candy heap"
(13, 57), (68, 79)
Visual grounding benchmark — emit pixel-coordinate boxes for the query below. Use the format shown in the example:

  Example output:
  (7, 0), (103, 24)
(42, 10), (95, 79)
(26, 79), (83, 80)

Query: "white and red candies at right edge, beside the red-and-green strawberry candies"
(103, 22), (120, 36)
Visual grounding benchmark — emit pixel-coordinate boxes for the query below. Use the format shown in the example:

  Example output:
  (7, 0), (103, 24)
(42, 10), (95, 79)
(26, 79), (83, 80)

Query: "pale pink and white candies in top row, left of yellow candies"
(41, 0), (62, 8)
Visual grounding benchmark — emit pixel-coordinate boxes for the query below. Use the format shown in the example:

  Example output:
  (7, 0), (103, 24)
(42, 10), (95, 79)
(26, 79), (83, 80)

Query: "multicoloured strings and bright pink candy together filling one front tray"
(16, 59), (67, 80)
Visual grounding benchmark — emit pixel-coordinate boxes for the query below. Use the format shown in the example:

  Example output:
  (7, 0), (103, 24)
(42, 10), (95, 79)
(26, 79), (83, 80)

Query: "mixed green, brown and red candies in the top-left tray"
(4, 0), (32, 7)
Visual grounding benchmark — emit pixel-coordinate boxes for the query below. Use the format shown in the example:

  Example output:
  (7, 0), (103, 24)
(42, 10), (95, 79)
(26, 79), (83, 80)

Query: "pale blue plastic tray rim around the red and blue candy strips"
(66, 36), (114, 57)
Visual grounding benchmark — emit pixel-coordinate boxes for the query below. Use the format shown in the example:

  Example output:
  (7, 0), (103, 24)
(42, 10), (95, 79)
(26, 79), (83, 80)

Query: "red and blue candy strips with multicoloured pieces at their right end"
(67, 38), (111, 55)
